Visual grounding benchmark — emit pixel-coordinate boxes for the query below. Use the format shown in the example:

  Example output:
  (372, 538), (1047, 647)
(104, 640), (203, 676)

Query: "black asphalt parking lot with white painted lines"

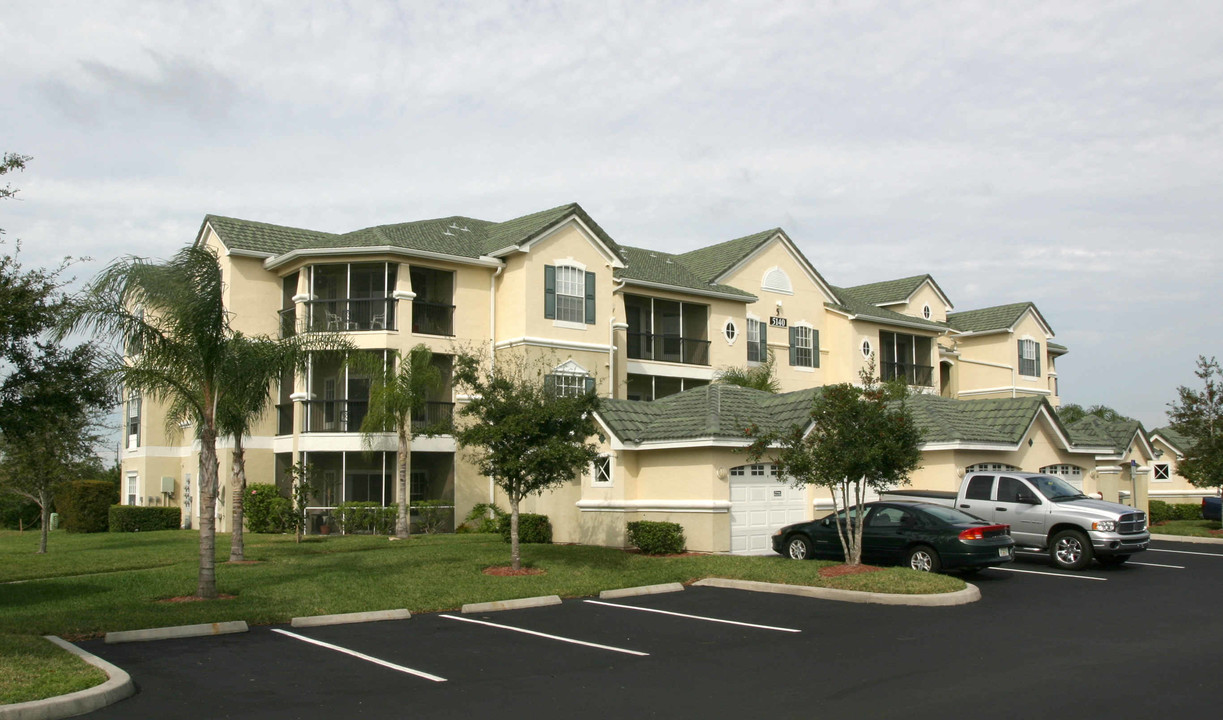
(81, 542), (1223, 719)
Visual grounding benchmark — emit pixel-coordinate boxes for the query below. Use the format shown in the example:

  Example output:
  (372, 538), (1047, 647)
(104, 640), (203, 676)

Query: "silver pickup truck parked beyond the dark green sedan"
(882, 472), (1151, 570)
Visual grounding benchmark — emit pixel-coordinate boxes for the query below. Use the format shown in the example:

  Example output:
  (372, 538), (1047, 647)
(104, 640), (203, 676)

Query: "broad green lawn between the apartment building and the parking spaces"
(0, 531), (965, 703)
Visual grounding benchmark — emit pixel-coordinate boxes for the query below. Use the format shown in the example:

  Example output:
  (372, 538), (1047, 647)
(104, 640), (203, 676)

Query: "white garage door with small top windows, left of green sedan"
(730, 465), (807, 555)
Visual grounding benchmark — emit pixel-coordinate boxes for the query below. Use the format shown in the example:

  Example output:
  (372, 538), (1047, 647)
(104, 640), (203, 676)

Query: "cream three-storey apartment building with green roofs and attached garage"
(124, 204), (1125, 553)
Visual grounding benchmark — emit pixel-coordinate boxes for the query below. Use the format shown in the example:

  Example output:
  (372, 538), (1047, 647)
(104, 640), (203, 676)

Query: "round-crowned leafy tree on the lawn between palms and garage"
(455, 354), (603, 570)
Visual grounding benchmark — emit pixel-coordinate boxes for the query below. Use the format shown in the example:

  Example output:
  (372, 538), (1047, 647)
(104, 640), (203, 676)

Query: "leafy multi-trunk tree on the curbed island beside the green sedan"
(747, 362), (921, 565)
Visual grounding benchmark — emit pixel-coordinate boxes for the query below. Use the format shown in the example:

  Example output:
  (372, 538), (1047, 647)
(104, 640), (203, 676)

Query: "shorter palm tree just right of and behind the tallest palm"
(215, 332), (351, 562)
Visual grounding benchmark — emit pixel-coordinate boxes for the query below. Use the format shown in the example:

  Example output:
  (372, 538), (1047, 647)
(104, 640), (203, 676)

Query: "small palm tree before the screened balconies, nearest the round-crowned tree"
(352, 345), (442, 538)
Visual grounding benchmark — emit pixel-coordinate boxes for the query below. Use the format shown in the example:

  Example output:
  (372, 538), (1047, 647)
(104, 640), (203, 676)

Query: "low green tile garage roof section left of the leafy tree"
(597, 383), (822, 444)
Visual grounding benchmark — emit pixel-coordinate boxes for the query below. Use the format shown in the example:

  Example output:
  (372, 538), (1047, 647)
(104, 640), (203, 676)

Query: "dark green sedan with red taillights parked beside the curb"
(773, 502), (1015, 572)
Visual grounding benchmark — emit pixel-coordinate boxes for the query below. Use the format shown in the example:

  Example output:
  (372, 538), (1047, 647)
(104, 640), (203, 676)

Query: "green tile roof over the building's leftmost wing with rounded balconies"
(201, 203), (623, 262)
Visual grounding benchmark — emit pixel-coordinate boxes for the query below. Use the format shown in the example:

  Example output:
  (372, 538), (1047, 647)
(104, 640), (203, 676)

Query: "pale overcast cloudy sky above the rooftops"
(0, 0), (1223, 427)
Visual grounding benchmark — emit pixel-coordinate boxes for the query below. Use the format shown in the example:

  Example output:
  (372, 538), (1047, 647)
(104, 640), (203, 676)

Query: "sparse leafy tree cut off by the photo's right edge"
(1168, 356), (1223, 498)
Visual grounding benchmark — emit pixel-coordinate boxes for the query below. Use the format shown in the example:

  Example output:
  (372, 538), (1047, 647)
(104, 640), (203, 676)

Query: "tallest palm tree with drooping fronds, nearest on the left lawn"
(57, 246), (232, 598)
